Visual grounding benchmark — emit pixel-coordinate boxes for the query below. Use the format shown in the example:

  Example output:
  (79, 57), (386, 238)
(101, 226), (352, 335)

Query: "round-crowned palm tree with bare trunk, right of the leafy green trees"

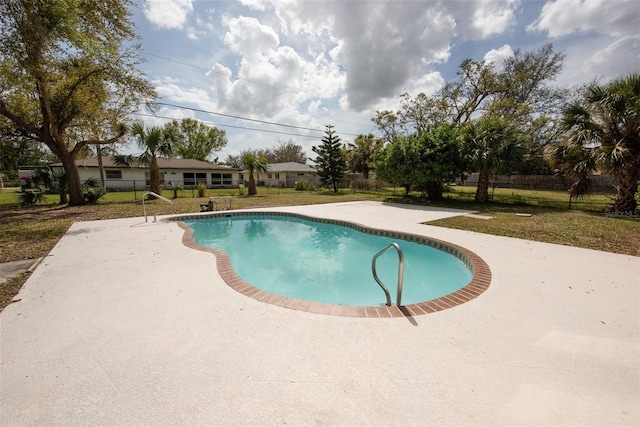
(463, 116), (524, 203)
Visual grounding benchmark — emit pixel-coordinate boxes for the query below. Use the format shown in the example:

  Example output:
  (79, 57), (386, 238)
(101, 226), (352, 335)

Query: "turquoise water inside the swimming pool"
(184, 214), (472, 306)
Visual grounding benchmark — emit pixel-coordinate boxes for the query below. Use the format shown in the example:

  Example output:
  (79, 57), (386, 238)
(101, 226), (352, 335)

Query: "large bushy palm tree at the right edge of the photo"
(556, 73), (640, 212)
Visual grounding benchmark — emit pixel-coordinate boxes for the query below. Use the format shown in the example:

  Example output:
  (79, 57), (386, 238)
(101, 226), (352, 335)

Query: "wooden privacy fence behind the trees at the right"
(462, 173), (615, 193)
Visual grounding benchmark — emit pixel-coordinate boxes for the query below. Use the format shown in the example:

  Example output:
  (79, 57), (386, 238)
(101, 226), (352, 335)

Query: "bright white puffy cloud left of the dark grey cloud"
(207, 13), (344, 121)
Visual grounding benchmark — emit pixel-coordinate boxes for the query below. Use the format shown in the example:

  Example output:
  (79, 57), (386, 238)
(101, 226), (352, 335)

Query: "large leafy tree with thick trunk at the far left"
(0, 0), (154, 205)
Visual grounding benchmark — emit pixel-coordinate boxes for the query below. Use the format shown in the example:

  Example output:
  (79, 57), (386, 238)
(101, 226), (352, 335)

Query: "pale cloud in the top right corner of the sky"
(527, 0), (640, 37)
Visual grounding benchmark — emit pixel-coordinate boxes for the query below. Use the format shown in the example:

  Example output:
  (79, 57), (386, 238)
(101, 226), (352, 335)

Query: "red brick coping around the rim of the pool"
(165, 211), (491, 318)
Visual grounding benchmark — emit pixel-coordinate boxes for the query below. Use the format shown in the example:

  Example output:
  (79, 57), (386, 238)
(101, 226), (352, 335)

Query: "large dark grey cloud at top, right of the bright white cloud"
(274, 1), (455, 110)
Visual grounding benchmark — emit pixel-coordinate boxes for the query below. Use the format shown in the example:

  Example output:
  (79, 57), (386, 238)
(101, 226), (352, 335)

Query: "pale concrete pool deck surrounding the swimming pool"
(0, 202), (640, 426)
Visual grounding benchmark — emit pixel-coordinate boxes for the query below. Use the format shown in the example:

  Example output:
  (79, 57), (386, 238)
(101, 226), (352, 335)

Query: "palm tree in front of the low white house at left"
(114, 122), (176, 194)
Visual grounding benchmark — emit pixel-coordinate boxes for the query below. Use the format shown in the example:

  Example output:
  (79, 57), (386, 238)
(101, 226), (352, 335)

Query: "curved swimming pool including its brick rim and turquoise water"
(173, 212), (490, 317)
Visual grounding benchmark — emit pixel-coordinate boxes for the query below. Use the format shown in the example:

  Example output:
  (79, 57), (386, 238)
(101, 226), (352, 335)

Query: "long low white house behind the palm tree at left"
(51, 157), (239, 191)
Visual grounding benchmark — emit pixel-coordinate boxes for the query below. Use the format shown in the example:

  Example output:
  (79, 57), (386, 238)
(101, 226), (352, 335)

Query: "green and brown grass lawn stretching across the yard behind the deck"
(0, 187), (640, 310)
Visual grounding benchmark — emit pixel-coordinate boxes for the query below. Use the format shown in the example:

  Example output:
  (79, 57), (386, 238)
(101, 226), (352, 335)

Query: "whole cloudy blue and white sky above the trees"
(126, 0), (640, 161)
